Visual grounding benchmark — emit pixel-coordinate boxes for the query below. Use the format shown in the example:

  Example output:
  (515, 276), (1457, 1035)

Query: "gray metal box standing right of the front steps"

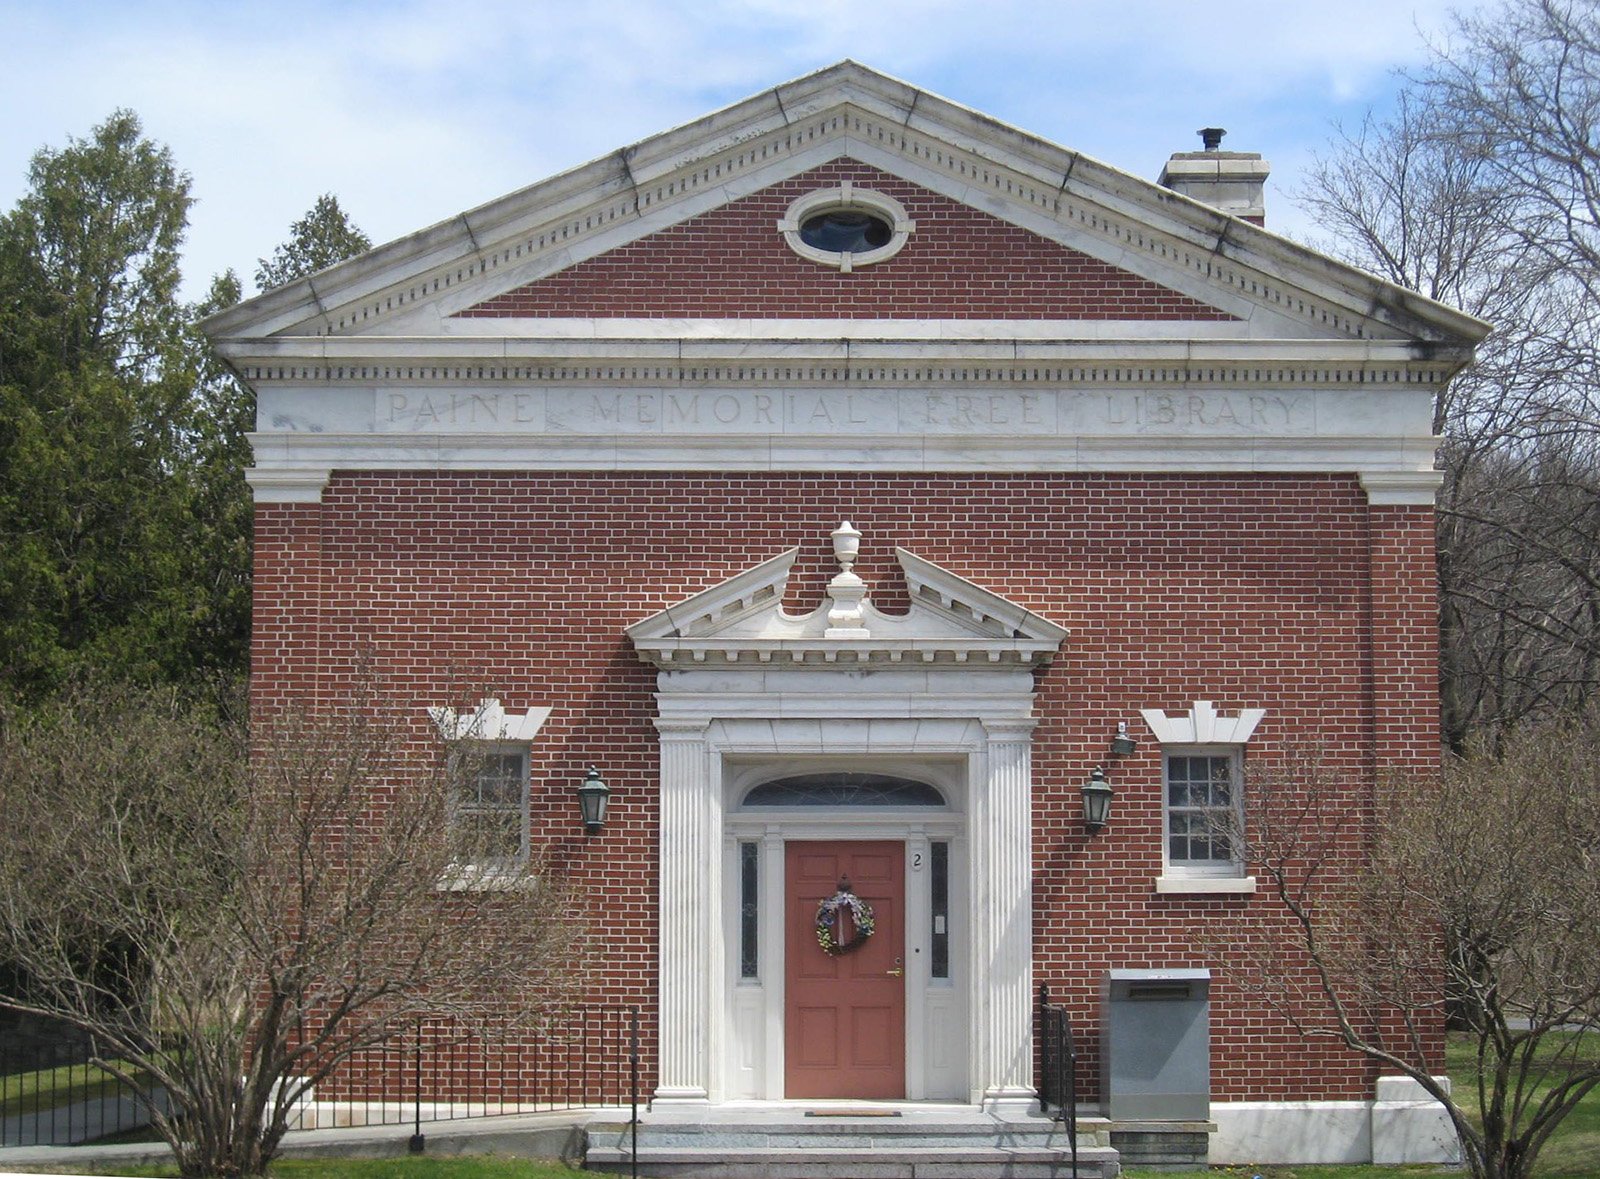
(1101, 969), (1211, 1121)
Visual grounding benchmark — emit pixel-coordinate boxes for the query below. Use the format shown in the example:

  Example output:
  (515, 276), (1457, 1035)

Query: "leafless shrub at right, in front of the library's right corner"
(1222, 726), (1600, 1179)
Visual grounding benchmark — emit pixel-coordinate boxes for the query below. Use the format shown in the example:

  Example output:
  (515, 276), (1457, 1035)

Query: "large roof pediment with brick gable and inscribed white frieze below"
(205, 62), (1488, 508)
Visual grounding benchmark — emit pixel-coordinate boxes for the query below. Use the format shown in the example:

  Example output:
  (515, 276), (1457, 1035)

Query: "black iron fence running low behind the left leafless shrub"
(0, 1005), (638, 1147)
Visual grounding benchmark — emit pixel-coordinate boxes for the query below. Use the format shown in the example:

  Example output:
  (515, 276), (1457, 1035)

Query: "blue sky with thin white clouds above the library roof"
(0, 0), (1480, 296)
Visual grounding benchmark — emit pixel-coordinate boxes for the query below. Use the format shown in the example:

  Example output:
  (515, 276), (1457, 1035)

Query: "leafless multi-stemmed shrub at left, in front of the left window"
(0, 688), (582, 1176)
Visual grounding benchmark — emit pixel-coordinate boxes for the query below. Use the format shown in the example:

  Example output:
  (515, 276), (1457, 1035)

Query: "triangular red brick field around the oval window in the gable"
(459, 158), (1234, 320)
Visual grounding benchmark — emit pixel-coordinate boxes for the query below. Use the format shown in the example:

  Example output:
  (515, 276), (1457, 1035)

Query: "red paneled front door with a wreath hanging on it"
(784, 841), (906, 1097)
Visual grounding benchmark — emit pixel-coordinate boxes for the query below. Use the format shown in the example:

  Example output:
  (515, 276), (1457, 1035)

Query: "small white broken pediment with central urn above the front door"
(627, 523), (1067, 670)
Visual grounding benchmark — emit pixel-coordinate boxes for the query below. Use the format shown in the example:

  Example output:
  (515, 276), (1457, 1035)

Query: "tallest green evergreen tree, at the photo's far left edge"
(0, 110), (197, 691)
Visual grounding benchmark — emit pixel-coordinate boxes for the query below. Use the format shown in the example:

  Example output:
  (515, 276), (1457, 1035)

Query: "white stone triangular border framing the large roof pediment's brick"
(208, 62), (1483, 353)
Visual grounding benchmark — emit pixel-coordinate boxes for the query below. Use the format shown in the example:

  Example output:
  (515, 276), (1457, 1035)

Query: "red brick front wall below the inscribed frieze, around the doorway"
(253, 470), (1438, 1101)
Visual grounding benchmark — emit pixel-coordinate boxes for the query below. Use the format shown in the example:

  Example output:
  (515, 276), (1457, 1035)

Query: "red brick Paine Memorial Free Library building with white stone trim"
(211, 62), (1483, 1161)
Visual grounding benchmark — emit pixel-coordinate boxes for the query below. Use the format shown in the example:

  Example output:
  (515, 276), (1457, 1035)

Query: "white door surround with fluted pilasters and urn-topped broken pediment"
(629, 525), (1066, 1104)
